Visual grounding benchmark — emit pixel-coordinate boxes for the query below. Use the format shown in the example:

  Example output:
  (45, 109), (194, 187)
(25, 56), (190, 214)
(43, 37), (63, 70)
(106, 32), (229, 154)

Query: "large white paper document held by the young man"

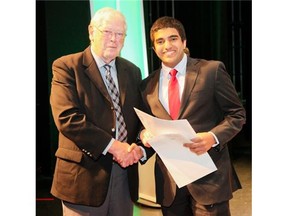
(134, 108), (217, 188)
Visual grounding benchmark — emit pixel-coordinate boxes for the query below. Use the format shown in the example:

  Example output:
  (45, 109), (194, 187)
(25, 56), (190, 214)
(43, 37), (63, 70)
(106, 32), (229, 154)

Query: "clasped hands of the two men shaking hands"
(108, 140), (143, 168)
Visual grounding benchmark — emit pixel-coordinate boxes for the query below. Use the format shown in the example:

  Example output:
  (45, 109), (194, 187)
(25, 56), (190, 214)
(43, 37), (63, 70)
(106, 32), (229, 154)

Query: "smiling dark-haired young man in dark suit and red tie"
(140, 17), (246, 216)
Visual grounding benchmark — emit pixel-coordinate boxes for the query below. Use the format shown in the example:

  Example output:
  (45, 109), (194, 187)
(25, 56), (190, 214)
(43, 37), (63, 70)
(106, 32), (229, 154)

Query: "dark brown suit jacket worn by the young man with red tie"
(141, 58), (246, 206)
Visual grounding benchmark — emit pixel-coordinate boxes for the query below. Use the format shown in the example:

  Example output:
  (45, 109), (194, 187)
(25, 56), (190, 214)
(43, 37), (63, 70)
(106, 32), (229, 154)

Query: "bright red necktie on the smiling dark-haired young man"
(168, 69), (180, 119)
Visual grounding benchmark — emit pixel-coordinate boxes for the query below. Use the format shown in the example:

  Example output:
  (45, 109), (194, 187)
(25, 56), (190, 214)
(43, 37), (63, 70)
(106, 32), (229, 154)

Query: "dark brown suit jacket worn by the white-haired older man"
(50, 47), (141, 206)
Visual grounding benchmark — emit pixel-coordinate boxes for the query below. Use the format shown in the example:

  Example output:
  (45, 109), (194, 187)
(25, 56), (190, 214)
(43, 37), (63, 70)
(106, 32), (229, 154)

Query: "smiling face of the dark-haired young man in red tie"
(154, 28), (186, 68)
